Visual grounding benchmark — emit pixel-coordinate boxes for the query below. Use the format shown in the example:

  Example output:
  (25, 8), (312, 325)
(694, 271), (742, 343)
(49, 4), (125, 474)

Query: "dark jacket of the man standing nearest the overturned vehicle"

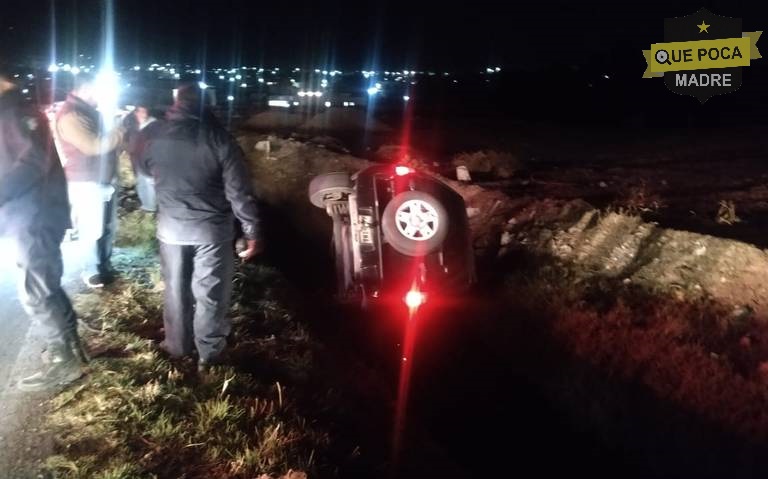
(134, 109), (260, 244)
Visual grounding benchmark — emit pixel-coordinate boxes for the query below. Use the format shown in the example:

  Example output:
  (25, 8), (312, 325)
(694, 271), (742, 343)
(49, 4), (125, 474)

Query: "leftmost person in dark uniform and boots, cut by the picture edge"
(0, 66), (86, 391)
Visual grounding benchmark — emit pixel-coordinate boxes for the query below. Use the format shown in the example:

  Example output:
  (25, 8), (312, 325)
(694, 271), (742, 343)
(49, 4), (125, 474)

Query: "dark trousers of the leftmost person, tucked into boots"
(15, 228), (77, 345)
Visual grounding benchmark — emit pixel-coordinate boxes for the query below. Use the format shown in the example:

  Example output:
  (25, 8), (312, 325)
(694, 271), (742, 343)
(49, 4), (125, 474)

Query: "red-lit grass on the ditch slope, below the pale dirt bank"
(506, 256), (768, 444)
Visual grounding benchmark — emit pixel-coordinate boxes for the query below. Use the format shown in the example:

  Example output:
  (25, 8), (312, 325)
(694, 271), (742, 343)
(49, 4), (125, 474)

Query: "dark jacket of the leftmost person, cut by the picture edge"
(0, 90), (70, 234)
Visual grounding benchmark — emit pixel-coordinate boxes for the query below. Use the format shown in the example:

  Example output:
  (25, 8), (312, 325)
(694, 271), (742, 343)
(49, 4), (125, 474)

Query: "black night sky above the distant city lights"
(0, 0), (768, 70)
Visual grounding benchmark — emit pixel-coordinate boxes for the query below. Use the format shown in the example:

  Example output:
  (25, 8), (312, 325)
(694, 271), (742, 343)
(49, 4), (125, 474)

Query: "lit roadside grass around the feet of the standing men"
(46, 218), (330, 479)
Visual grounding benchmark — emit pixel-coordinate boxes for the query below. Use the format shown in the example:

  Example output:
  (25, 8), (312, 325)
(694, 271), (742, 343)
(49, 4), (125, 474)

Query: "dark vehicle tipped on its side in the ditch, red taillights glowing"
(309, 165), (475, 307)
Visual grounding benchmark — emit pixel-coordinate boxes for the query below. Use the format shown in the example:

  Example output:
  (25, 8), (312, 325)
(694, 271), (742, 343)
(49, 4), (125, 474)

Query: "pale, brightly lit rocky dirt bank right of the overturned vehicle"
(500, 202), (768, 317)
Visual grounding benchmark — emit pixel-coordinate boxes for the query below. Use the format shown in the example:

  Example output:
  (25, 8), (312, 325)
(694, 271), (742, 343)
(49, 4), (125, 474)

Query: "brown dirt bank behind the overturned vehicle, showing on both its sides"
(241, 136), (768, 317)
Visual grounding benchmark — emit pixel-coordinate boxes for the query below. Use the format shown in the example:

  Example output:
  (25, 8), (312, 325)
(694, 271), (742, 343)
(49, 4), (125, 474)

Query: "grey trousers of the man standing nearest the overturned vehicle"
(160, 241), (235, 360)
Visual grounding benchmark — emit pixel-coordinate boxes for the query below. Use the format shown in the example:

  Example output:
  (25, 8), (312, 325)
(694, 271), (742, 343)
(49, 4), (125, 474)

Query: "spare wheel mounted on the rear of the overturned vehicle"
(381, 191), (449, 256)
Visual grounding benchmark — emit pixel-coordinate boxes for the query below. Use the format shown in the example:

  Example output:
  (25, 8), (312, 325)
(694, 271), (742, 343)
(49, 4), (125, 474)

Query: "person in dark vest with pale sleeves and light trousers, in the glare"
(54, 74), (125, 288)
